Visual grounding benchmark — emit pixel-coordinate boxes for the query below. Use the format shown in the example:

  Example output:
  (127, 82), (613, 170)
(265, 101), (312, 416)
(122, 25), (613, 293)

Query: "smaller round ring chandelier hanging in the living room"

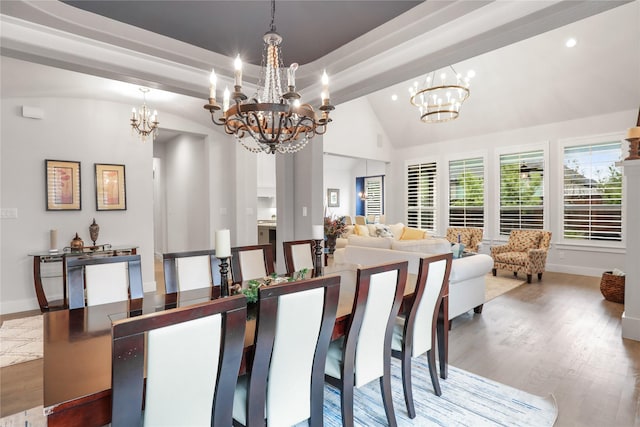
(409, 66), (475, 123)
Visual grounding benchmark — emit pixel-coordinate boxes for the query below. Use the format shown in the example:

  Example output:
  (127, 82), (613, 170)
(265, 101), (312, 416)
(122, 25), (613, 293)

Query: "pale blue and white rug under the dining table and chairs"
(0, 356), (558, 427)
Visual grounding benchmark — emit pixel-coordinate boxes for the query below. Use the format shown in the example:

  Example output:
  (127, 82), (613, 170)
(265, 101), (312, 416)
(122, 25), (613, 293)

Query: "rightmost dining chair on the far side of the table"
(231, 244), (275, 283)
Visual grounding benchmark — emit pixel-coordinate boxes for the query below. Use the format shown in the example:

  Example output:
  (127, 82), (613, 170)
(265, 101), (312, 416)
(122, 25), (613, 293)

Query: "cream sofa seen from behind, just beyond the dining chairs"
(333, 244), (493, 319)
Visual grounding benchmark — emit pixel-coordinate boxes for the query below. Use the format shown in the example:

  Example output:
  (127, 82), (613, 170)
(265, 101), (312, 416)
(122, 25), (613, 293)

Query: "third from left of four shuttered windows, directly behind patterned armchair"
(500, 150), (544, 235)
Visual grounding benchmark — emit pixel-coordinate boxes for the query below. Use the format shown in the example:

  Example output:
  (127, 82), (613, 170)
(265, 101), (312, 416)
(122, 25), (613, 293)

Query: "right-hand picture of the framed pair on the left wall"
(96, 163), (127, 211)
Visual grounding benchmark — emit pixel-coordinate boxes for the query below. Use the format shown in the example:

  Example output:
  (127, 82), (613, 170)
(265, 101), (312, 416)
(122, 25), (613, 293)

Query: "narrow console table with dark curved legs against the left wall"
(29, 244), (138, 313)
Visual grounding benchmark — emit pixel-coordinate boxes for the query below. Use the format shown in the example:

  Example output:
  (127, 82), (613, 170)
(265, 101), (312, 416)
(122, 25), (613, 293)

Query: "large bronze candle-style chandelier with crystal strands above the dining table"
(204, 0), (334, 154)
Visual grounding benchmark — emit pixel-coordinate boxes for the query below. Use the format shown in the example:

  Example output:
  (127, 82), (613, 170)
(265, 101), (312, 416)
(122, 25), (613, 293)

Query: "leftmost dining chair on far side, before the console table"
(64, 255), (144, 309)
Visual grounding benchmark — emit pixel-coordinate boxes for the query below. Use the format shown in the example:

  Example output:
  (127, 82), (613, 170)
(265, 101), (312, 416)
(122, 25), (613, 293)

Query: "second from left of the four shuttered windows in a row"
(449, 157), (484, 227)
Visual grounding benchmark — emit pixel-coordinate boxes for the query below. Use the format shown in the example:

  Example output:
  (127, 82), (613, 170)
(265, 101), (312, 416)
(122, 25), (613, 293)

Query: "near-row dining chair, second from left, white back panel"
(234, 276), (340, 426)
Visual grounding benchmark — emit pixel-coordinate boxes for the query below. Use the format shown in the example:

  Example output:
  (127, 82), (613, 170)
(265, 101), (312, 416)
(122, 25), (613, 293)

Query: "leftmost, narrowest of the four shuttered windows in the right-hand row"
(407, 162), (436, 231)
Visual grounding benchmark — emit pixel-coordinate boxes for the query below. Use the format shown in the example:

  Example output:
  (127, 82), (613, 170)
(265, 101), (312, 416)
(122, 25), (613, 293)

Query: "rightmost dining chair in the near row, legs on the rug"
(391, 253), (453, 418)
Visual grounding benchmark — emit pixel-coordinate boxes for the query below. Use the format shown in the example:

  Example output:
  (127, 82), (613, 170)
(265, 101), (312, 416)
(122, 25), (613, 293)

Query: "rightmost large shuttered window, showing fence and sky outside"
(563, 142), (622, 242)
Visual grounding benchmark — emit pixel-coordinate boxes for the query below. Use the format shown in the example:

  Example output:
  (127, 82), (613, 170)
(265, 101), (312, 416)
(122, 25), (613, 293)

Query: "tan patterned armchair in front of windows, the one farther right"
(491, 230), (551, 283)
